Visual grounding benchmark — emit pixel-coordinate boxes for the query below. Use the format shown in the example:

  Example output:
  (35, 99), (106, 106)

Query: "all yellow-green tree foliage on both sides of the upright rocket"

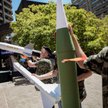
(11, 3), (108, 54)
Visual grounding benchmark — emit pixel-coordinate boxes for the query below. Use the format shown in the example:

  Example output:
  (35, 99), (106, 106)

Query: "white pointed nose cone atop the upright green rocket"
(56, 0), (68, 29)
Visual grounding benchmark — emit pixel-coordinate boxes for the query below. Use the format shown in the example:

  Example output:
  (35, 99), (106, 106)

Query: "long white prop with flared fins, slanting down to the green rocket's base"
(12, 58), (61, 108)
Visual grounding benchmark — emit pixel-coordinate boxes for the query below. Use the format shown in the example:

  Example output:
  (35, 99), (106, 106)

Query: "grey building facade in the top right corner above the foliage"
(72, 0), (108, 18)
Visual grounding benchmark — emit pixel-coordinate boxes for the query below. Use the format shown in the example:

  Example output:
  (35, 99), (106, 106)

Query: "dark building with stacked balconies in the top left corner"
(0, 0), (13, 25)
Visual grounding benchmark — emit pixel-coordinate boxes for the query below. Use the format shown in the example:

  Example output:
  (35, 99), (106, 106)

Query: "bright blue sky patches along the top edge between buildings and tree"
(12, 0), (71, 17)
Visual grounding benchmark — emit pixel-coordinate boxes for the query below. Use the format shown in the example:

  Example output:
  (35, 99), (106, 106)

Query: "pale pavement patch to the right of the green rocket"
(82, 74), (102, 108)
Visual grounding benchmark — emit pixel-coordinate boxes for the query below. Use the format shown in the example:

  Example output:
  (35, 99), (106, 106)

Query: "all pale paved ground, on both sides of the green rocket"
(0, 74), (102, 108)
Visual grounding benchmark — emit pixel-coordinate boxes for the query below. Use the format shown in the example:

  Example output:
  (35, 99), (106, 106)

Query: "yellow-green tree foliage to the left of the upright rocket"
(11, 4), (56, 50)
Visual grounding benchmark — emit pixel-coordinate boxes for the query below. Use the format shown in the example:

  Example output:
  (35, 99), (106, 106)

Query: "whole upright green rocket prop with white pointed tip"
(56, 0), (80, 108)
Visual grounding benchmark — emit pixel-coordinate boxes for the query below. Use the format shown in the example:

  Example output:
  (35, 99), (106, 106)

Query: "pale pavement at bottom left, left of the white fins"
(0, 78), (43, 108)
